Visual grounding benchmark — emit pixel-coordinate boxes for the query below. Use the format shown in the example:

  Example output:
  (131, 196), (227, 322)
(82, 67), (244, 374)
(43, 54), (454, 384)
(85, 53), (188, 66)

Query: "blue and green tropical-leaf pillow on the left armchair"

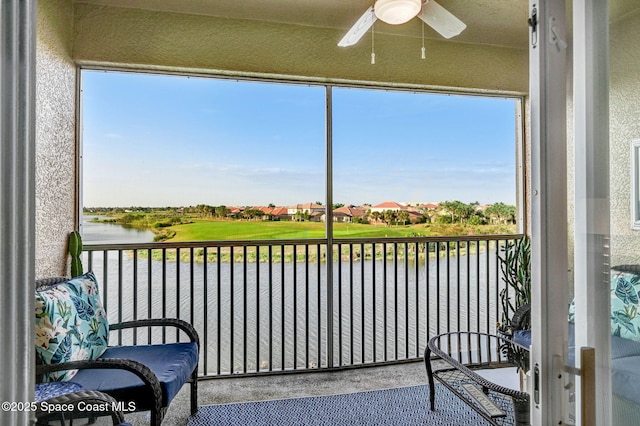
(35, 272), (109, 381)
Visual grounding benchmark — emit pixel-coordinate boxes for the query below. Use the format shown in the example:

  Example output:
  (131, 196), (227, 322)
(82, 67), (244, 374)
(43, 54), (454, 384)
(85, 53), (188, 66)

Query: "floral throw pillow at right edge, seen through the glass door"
(611, 270), (640, 341)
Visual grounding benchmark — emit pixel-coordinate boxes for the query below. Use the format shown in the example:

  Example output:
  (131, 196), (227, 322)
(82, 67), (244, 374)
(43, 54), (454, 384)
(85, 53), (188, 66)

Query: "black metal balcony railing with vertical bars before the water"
(84, 235), (521, 377)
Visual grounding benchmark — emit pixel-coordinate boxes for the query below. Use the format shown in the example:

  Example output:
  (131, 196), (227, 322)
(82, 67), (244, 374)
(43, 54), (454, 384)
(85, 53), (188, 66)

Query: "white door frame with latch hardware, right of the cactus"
(529, 0), (569, 426)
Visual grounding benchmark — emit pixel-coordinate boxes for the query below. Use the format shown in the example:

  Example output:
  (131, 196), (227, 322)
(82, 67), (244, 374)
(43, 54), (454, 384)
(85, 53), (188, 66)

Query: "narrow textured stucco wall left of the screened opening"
(36, 0), (76, 277)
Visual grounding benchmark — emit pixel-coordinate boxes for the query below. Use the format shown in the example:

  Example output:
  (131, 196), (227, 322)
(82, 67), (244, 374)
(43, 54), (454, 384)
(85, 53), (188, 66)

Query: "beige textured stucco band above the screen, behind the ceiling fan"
(73, 3), (528, 93)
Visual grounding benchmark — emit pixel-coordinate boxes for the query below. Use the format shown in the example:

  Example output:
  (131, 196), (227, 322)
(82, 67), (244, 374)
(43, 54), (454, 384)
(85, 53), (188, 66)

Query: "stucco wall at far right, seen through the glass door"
(610, 12), (640, 265)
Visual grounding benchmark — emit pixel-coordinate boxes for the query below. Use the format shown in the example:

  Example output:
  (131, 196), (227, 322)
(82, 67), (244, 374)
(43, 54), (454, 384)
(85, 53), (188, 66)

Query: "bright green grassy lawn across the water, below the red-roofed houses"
(167, 219), (516, 241)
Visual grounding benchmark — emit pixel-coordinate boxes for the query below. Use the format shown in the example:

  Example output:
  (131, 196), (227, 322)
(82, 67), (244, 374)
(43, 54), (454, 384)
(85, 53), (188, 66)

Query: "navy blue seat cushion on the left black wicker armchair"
(73, 342), (198, 410)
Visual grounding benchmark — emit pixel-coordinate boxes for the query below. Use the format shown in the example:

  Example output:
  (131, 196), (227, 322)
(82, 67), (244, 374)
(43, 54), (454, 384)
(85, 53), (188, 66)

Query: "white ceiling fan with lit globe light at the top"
(338, 0), (467, 47)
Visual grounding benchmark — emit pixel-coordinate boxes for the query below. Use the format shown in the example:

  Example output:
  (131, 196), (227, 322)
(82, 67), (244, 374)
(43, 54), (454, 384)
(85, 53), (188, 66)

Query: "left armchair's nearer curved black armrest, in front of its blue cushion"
(36, 358), (163, 412)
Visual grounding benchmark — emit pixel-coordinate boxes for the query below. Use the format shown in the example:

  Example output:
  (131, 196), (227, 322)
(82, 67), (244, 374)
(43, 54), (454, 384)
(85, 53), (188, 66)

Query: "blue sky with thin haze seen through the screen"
(82, 71), (516, 207)
